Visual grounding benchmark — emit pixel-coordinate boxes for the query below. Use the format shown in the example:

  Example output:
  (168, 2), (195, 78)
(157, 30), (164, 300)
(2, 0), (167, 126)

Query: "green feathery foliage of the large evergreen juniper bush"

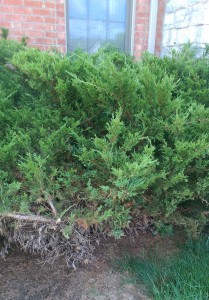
(0, 39), (209, 237)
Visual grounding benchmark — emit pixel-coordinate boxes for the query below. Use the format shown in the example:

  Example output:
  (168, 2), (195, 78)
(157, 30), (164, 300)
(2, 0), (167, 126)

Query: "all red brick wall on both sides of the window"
(0, 0), (165, 57)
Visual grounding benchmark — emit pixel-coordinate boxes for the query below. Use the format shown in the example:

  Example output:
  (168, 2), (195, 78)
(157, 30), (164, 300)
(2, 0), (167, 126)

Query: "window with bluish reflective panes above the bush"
(67, 0), (132, 53)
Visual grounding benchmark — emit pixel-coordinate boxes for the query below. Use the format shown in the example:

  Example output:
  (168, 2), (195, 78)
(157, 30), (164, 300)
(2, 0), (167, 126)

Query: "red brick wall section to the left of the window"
(0, 0), (66, 52)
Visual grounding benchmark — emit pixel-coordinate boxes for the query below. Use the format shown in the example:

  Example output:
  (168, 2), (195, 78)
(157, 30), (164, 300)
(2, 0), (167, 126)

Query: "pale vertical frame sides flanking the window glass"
(65, 0), (134, 54)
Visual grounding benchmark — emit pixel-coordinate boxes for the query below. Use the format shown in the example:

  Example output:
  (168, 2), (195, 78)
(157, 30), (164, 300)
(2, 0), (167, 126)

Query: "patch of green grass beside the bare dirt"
(120, 239), (209, 300)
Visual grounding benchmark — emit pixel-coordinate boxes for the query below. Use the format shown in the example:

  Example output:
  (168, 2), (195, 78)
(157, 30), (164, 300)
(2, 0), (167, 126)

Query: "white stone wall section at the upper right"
(162, 0), (209, 55)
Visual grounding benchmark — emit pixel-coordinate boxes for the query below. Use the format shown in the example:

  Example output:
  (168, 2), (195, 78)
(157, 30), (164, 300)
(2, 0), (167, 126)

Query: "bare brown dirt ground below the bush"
(0, 234), (180, 300)
